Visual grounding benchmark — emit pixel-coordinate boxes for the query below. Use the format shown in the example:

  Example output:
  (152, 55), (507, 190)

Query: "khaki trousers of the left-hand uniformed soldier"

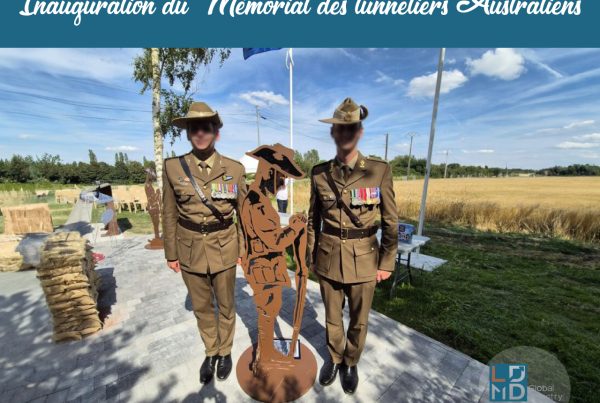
(181, 266), (235, 357)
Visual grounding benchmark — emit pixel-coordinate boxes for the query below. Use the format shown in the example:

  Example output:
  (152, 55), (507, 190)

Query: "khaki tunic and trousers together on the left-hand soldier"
(163, 152), (246, 356)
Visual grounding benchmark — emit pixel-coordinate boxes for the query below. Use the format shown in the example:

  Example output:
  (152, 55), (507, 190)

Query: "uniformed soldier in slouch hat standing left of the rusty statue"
(163, 102), (246, 383)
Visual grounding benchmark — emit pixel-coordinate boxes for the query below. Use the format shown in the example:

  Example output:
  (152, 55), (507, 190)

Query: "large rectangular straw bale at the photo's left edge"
(2, 203), (54, 235)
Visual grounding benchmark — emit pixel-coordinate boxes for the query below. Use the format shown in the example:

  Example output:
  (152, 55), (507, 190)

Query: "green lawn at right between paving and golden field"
(373, 228), (600, 402)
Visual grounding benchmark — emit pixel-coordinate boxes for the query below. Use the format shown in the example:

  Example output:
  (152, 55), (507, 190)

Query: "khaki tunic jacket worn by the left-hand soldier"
(162, 152), (247, 273)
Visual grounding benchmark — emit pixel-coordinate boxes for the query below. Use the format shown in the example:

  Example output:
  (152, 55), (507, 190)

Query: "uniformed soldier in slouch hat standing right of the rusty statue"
(308, 98), (398, 394)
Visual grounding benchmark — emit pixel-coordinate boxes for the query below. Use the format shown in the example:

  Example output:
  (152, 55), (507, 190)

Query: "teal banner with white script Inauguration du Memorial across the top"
(0, 0), (600, 47)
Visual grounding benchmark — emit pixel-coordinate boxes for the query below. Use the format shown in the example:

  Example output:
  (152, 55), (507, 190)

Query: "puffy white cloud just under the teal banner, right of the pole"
(467, 48), (525, 81)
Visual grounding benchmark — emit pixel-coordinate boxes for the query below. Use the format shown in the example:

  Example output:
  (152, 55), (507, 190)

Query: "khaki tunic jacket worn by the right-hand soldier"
(308, 153), (398, 284)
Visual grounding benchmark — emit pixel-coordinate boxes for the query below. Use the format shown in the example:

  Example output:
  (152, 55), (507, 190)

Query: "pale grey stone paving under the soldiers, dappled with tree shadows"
(0, 237), (544, 403)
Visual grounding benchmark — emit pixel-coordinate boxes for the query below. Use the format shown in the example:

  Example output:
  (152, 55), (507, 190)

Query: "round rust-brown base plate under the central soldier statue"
(236, 343), (317, 403)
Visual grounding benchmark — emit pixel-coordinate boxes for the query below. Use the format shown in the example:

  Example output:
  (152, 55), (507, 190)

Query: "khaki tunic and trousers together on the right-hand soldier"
(308, 153), (398, 366)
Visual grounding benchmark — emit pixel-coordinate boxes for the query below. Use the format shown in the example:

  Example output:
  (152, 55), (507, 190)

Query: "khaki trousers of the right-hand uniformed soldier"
(319, 277), (375, 366)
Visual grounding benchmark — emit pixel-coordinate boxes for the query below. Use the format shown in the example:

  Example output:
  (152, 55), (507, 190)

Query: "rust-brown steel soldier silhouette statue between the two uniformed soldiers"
(241, 144), (308, 378)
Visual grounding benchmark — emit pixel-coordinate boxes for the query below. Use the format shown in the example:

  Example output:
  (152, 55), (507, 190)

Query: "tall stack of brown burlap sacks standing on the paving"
(37, 232), (102, 342)
